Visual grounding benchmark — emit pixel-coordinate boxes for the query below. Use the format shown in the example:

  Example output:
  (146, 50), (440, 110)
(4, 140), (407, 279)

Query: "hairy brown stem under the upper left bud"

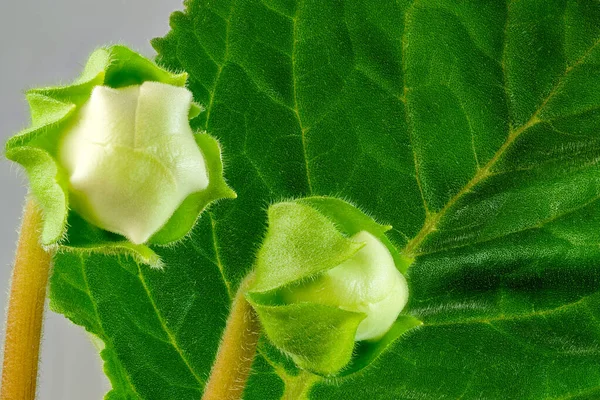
(0, 199), (51, 400)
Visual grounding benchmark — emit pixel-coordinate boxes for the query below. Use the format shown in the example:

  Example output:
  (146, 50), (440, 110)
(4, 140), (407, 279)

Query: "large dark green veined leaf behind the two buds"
(51, 0), (600, 400)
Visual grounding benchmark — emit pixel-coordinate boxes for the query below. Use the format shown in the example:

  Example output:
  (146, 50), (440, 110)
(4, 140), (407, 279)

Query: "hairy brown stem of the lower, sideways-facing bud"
(202, 274), (260, 400)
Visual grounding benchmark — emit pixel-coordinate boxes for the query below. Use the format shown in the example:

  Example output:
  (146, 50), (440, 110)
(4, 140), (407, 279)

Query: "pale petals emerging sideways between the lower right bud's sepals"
(282, 231), (408, 341)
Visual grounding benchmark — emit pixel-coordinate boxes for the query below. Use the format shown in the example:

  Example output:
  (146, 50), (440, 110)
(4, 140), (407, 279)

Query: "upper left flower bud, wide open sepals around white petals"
(6, 46), (235, 261)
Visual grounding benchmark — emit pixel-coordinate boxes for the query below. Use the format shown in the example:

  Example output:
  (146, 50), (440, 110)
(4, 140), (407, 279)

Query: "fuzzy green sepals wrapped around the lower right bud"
(246, 196), (422, 376)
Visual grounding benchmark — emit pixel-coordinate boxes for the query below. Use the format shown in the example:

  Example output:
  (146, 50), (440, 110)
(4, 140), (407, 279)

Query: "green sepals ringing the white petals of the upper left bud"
(5, 45), (235, 266)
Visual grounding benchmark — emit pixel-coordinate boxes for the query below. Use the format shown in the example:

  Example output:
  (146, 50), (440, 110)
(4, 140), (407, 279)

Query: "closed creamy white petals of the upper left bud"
(58, 81), (208, 244)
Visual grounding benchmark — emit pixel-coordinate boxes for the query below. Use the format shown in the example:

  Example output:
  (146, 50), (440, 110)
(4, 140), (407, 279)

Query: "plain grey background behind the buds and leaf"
(0, 0), (182, 400)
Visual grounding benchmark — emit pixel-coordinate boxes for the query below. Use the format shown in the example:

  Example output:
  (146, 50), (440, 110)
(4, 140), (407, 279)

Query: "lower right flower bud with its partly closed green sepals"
(247, 197), (421, 376)
